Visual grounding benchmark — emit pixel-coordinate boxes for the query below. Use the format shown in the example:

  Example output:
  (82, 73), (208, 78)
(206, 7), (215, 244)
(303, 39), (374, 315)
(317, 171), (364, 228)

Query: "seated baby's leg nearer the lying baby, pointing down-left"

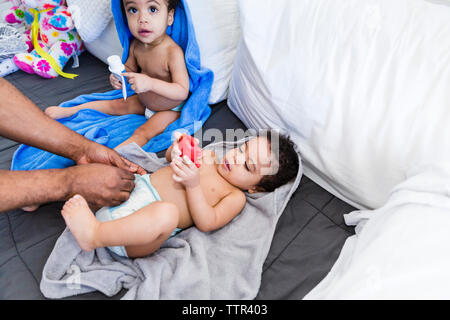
(115, 110), (181, 149)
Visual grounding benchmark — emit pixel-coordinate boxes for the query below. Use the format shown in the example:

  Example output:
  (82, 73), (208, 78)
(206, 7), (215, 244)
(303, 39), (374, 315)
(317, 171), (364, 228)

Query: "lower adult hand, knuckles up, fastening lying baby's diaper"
(67, 164), (134, 207)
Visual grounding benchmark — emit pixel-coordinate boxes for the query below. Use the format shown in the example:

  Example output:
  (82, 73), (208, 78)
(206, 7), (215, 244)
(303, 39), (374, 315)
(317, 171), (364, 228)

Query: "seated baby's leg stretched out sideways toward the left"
(45, 95), (145, 119)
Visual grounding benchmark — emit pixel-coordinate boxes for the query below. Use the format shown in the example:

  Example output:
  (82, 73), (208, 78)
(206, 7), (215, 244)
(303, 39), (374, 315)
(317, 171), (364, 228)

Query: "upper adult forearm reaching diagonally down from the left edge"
(0, 78), (90, 160)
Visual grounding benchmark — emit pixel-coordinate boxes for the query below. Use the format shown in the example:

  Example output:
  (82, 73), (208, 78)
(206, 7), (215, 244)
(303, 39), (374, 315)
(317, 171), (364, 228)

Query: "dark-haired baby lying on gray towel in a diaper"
(61, 131), (299, 258)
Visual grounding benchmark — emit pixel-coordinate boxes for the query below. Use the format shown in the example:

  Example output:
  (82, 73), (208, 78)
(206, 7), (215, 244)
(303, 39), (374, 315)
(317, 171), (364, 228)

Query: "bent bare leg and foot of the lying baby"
(61, 195), (179, 258)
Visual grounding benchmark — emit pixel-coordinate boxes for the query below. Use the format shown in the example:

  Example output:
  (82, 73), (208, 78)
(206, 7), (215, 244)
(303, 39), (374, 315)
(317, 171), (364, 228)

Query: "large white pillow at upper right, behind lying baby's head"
(229, 0), (450, 208)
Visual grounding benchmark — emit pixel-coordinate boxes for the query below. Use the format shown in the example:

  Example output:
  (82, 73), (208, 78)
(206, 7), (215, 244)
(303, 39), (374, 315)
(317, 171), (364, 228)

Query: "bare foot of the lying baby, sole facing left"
(61, 195), (100, 251)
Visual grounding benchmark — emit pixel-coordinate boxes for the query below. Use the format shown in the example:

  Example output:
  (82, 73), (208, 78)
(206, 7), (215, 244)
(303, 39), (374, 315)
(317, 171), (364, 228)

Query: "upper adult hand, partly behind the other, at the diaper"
(74, 143), (147, 175)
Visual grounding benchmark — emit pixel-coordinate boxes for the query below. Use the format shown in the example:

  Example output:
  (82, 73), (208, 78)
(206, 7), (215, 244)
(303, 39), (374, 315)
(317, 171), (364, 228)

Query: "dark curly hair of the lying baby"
(256, 130), (300, 192)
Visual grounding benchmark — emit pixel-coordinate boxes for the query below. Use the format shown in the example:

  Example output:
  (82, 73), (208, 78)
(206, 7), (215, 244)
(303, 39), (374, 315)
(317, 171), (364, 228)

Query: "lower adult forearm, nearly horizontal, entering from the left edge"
(0, 169), (72, 212)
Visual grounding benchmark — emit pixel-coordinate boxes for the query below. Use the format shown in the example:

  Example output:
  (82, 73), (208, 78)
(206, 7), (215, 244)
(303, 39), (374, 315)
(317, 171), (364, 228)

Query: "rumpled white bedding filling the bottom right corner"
(305, 163), (450, 299)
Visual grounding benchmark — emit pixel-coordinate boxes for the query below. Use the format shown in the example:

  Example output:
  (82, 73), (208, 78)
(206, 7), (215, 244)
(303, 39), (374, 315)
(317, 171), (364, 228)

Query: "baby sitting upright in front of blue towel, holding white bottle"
(45, 0), (189, 148)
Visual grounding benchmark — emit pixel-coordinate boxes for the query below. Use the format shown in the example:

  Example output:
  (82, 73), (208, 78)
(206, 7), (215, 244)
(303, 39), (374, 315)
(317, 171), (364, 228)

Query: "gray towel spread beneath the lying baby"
(40, 140), (303, 300)
